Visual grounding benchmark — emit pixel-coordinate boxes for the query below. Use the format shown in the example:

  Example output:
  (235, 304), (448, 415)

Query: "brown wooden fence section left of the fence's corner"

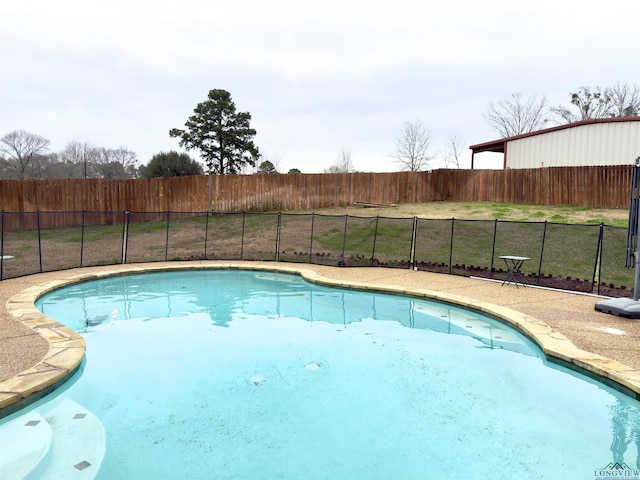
(0, 172), (429, 213)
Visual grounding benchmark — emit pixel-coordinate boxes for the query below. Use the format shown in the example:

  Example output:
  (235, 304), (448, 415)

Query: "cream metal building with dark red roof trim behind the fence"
(469, 117), (640, 169)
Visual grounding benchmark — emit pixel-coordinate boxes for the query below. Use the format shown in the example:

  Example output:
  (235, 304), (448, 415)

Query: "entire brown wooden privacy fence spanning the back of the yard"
(0, 165), (632, 228)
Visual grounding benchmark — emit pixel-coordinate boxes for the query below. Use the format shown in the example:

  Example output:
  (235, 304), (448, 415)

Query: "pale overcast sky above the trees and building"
(0, 0), (640, 173)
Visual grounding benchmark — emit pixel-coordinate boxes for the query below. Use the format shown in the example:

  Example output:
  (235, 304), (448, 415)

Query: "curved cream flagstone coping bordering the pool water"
(0, 261), (640, 418)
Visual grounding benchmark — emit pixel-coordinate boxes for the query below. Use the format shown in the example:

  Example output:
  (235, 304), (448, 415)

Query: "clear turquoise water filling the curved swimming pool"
(16, 270), (640, 480)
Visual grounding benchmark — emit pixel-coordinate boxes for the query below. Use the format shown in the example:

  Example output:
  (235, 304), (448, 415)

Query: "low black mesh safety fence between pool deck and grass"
(0, 211), (635, 296)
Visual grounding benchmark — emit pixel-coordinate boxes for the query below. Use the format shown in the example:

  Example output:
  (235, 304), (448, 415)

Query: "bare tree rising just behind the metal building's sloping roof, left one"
(484, 93), (547, 137)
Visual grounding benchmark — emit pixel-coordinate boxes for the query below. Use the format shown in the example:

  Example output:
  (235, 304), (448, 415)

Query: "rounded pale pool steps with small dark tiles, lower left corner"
(0, 399), (106, 480)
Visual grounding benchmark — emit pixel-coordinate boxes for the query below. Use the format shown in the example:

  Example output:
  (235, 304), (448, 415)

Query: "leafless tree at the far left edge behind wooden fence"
(0, 130), (50, 180)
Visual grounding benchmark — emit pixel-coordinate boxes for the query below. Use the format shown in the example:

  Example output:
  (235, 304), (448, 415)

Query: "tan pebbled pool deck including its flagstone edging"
(0, 261), (640, 416)
